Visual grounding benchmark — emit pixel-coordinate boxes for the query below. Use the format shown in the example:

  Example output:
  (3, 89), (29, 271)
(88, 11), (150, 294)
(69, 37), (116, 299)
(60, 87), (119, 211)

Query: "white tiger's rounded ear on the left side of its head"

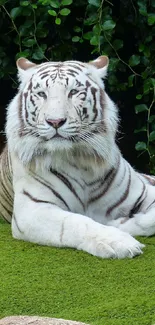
(16, 58), (37, 84)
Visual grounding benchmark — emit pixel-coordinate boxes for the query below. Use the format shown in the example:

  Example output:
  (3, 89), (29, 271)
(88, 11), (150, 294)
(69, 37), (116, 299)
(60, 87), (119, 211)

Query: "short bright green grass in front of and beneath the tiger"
(0, 223), (155, 325)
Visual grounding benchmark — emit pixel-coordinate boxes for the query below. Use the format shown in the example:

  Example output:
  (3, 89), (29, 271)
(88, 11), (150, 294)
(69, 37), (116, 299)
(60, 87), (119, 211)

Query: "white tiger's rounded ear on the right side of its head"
(89, 55), (109, 78)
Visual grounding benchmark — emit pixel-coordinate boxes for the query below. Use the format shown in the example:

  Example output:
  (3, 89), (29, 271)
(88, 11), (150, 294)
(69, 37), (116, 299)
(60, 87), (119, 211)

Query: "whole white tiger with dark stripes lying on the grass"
(0, 56), (155, 258)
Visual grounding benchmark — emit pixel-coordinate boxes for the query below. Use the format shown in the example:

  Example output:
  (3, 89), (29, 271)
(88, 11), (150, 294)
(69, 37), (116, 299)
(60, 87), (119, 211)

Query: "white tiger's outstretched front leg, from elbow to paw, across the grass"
(12, 190), (144, 258)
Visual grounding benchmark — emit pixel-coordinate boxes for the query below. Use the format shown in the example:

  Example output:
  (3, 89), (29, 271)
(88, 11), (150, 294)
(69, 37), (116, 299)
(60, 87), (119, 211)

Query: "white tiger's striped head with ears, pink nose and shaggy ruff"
(6, 56), (117, 163)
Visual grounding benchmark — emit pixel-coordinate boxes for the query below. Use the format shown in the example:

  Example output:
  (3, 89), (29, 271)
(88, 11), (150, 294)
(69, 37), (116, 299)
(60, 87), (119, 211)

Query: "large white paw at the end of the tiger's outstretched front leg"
(79, 225), (144, 259)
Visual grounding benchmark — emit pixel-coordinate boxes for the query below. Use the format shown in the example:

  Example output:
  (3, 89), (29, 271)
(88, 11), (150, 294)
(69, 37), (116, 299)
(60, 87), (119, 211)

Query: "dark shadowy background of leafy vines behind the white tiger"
(0, 0), (155, 172)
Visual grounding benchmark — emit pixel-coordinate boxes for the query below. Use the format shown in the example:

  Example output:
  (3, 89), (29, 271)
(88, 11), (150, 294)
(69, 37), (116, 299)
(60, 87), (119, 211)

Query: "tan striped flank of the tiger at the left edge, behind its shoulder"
(0, 145), (14, 223)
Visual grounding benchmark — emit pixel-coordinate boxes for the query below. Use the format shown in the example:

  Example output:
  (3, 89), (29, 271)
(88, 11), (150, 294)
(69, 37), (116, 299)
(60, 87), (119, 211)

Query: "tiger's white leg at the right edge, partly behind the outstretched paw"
(109, 205), (155, 236)
